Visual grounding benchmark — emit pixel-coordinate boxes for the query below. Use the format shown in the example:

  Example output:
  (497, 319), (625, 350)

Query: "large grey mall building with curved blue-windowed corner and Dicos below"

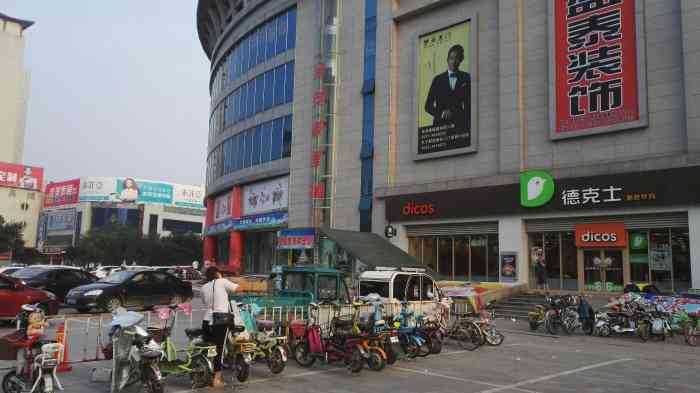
(197, 0), (700, 292)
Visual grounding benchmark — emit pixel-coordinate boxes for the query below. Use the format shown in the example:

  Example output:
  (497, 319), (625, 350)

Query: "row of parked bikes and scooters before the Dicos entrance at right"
(528, 292), (700, 346)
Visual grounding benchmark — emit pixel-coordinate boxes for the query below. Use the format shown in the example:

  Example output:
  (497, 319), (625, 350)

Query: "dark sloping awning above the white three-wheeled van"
(320, 228), (424, 268)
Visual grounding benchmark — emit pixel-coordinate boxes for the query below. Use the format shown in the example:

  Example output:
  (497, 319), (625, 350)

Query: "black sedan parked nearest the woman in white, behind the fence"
(66, 270), (193, 312)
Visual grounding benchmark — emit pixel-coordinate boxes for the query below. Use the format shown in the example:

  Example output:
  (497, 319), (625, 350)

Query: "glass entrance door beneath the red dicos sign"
(583, 250), (624, 292)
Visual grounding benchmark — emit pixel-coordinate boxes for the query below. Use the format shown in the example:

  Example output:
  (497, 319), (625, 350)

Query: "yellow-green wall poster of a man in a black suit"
(415, 21), (476, 159)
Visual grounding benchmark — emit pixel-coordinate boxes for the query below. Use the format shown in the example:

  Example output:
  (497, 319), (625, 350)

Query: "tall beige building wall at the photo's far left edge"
(0, 21), (29, 163)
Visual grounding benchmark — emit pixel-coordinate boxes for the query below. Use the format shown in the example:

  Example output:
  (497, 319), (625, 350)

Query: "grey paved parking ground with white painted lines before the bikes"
(2, 320), (700, 393)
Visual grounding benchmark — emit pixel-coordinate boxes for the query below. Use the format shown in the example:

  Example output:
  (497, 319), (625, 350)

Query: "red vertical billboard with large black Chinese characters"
(549, 0), (648, 139)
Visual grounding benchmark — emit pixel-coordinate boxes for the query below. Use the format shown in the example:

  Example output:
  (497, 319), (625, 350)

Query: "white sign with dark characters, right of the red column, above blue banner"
(243, 176), (289, 216)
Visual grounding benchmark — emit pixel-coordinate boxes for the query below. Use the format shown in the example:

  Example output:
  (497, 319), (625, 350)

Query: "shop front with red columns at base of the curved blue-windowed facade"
(204, 177), (289, 274)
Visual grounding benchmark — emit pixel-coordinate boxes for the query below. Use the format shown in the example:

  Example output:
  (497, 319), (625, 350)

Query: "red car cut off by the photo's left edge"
(0, 274), (58, 321)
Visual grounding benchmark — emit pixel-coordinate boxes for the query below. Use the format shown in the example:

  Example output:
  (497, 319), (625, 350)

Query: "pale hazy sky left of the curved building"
(0, 0), (209, 184)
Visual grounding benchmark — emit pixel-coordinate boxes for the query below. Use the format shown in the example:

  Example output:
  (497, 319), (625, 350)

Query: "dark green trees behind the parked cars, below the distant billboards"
(66, 224), (202, 266)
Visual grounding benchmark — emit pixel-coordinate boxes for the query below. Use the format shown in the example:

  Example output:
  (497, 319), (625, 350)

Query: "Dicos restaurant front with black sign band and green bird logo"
(385, 167), (700, 293)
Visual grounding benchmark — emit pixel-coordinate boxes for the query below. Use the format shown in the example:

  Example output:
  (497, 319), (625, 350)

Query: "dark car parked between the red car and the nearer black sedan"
(10, 266), (97, 301)
